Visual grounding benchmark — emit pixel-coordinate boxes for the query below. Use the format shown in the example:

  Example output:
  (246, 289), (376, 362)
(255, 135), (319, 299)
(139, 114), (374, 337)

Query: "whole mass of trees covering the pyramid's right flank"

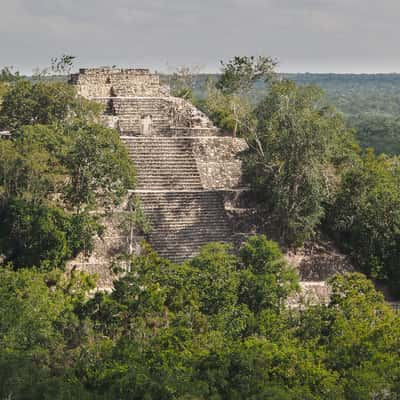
(200, 57), (400, 291)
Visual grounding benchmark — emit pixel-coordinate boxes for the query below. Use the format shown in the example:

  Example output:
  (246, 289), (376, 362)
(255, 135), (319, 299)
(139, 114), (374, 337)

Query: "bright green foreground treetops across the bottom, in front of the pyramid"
(0, 236), (400, 400)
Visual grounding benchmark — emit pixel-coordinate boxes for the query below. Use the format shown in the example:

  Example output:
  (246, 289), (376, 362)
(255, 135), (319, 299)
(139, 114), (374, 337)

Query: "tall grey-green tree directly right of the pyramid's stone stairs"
(244, 81), (355, 246)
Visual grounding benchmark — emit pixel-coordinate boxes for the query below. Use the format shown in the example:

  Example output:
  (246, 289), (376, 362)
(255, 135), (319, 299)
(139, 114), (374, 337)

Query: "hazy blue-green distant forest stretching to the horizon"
(175, 73), (400, 154)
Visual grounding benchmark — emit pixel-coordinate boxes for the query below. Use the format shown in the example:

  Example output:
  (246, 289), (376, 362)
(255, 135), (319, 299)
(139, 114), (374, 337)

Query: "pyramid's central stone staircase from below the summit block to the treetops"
(95, 81), (238, 262)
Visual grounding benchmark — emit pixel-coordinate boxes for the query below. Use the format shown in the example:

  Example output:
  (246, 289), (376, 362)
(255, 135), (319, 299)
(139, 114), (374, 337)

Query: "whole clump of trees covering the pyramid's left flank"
(0, 79), (135, 269)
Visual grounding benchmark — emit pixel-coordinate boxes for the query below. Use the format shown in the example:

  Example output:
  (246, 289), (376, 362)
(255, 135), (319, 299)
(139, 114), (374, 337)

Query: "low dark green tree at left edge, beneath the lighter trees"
(0, 200), (102, 269)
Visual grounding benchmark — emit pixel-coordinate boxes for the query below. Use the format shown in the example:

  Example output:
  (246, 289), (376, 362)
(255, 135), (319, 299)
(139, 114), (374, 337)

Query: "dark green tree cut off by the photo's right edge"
(327, 150), (400, 288)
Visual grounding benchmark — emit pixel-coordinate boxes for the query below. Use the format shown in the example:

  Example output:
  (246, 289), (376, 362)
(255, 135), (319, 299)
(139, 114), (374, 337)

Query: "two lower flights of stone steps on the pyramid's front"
(122, 131), (232, 262)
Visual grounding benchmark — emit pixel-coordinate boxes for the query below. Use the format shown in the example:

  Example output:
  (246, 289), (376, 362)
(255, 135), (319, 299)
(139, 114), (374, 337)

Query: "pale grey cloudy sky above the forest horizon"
(0, 0), (400, 73)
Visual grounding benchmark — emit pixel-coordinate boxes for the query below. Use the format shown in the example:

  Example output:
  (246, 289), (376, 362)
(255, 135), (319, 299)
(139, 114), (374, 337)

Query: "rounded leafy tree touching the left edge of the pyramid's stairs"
(62, 121), (135, 212)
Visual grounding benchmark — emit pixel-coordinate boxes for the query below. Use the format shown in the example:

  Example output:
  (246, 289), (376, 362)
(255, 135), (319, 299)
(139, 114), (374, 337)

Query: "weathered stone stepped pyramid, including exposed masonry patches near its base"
(66, 68), (346, 298)
